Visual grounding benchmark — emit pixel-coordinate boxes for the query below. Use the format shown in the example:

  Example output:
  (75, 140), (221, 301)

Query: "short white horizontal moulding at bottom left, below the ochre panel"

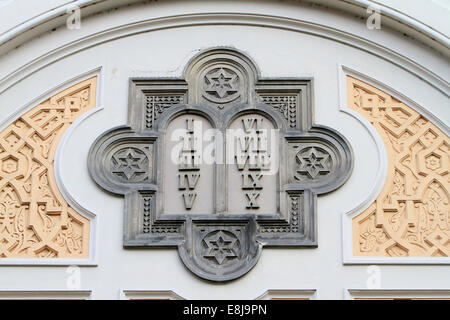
(0, 289), (92, 300)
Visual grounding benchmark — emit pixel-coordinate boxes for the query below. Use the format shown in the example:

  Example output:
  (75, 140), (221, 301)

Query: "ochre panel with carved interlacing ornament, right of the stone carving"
(347, 77), (450, 257)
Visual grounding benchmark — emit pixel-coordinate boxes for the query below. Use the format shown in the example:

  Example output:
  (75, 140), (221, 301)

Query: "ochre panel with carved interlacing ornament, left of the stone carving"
(0, 77), (97, 258)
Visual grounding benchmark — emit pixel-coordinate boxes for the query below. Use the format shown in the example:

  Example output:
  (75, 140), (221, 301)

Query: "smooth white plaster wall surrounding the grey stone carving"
(0, 1), (450, 299)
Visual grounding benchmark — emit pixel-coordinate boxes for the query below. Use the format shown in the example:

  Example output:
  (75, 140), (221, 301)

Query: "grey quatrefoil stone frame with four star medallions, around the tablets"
(88, 48), (353, 281)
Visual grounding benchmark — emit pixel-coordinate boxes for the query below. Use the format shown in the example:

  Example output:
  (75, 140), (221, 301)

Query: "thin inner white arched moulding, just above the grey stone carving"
(0, 13), (450, 96)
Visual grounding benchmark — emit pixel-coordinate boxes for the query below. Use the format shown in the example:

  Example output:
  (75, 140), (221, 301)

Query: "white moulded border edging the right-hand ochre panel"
(338, 65), (450, 265)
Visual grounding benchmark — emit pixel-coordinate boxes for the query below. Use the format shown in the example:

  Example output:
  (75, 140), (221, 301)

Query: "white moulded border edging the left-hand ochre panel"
(0, 67), (103, 266)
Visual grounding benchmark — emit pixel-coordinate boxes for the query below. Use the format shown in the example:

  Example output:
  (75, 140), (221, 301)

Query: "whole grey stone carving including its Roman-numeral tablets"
(88, 48), (353, 281)
